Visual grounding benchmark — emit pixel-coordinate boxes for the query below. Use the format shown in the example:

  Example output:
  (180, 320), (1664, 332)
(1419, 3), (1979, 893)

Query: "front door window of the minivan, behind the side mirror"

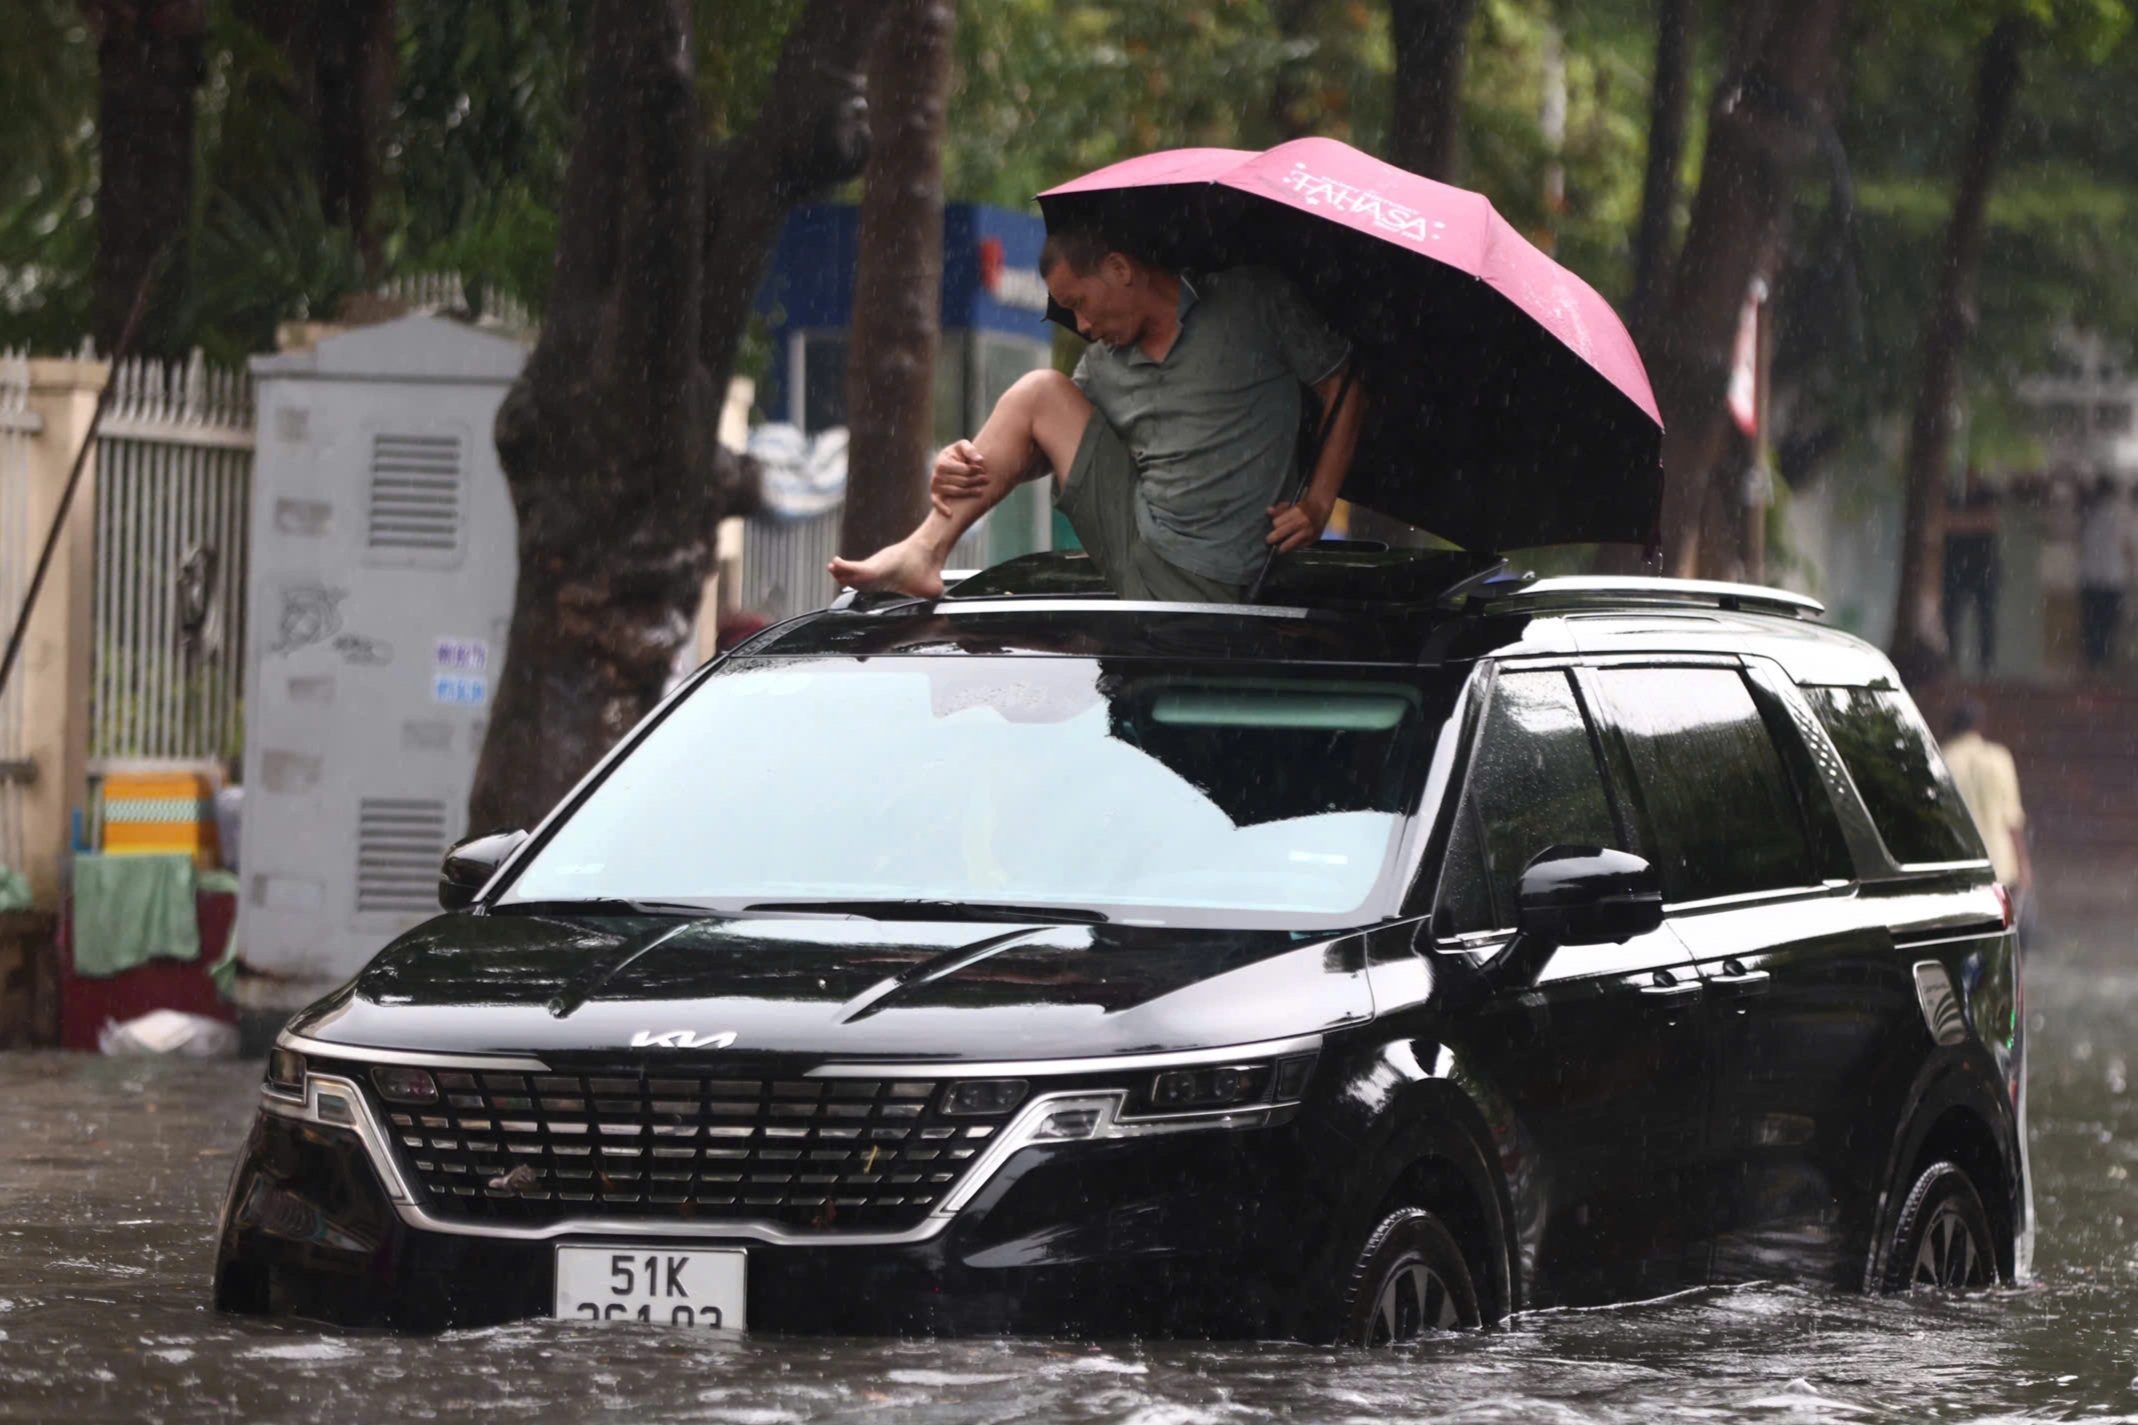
(1435, 671), (1618, 936)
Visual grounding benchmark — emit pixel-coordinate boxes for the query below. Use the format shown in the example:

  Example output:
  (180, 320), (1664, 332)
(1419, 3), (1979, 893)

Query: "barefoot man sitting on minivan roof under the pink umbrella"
(832, 229), (1362, 602)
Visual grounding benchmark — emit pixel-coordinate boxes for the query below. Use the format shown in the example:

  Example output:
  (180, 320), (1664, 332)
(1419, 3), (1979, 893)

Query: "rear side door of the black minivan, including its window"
(1584, 662), (1914, 1284)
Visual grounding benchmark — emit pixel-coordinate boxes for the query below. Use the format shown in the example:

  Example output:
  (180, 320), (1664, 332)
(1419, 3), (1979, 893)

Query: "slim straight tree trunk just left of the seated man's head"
(838, 0), (958, 558)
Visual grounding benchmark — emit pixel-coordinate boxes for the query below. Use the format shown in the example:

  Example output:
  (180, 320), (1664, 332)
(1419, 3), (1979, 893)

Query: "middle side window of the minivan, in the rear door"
(1595, 669), (1819, 902)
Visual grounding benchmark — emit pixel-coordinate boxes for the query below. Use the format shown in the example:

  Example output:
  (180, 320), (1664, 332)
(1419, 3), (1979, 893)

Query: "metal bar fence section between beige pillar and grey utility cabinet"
(90, 355), (252, 761)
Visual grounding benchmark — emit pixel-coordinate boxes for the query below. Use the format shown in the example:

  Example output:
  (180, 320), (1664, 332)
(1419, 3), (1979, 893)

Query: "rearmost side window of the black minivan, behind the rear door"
(1804, 688), (1984, 865)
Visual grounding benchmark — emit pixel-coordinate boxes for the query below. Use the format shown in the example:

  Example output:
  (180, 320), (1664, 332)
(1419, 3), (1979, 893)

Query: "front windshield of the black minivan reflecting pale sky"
(502, 658), (1458, 927)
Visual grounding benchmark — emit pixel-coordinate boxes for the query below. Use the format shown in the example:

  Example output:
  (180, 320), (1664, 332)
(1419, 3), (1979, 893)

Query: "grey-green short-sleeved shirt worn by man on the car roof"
(1075, 267), (1351, 583)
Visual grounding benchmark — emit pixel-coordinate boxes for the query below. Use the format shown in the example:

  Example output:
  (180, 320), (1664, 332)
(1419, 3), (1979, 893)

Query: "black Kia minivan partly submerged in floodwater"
(214, 547), (2033, 1344)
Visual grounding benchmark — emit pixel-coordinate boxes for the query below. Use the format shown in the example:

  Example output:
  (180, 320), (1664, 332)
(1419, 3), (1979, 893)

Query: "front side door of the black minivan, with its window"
(1435, 667), (1706, 1305)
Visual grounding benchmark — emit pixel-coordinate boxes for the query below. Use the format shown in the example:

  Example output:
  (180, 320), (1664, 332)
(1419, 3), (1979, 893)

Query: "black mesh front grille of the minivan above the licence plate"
(366, 1070), (996, 1233)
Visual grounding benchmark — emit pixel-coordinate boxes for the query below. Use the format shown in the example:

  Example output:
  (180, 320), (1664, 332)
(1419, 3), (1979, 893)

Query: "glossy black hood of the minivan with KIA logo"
(291, 914), (1373, 1062)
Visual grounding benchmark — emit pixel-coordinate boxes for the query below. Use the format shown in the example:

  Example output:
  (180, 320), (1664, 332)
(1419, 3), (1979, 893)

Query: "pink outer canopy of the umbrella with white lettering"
(1039, 139), (1663, 425)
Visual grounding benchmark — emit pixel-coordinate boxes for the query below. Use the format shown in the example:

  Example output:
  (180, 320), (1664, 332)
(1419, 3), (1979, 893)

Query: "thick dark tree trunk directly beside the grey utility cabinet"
(468, 0), (718, 831)
